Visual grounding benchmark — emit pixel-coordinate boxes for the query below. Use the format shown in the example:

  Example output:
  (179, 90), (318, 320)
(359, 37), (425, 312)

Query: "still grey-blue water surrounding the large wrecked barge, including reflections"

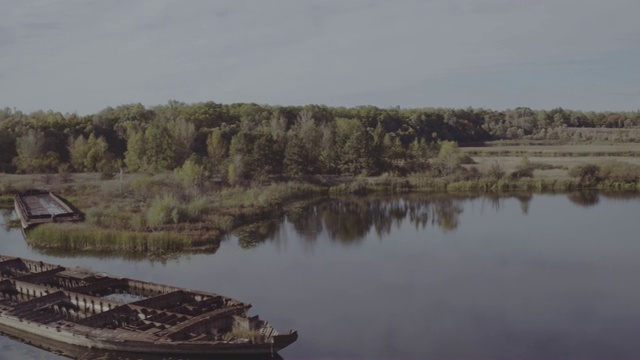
(0, 194), (640, 359)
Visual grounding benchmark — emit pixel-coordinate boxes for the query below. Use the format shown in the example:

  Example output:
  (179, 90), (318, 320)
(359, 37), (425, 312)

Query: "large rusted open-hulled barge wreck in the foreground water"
(0, 255), (298, 356)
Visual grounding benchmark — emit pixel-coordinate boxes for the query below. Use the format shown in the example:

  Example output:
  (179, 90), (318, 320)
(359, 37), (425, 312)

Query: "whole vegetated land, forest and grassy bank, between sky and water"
(0, 101), (640, 253)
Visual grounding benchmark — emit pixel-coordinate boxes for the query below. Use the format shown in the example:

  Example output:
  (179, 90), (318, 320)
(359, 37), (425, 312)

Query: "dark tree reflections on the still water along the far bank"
(236, 191), (640, 248)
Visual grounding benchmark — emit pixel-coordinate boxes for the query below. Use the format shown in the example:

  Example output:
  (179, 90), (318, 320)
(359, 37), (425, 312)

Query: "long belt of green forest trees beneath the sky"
(0, 101), (640, 179)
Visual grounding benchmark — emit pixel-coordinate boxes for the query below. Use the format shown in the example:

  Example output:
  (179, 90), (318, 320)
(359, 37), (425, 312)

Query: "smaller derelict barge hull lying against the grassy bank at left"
(14, 191), (82, 229)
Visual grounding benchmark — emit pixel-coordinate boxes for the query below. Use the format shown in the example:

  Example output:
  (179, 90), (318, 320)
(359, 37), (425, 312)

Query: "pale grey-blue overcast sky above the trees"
(0, 0), (640, 114)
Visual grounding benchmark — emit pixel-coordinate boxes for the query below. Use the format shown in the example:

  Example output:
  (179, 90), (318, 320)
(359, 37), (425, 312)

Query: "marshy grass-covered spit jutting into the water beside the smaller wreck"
(7, 173), (326, 254)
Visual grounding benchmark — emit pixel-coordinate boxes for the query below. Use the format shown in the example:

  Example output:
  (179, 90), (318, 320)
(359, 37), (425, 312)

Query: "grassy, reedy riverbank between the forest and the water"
(0, 150), (640, 254)
